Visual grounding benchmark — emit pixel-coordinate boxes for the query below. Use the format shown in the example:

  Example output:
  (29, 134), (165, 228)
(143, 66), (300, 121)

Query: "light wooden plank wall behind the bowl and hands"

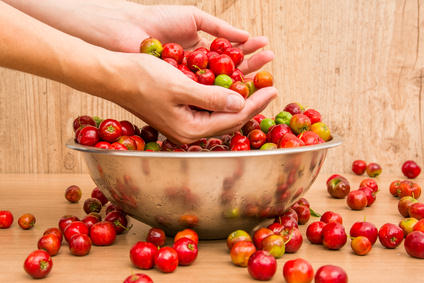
(0, 0), (424, 174)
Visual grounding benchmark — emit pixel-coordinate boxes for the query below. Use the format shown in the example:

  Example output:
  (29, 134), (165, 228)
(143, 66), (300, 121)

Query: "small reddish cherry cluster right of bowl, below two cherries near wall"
(327, 174), (378, 210)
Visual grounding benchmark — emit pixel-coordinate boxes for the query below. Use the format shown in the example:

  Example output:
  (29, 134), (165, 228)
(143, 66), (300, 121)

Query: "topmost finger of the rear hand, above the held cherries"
(194, 8), (249, 42)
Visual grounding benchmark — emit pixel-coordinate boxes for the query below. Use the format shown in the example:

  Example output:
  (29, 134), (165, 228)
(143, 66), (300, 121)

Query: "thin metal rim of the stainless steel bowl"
(66, 136), (342, 159)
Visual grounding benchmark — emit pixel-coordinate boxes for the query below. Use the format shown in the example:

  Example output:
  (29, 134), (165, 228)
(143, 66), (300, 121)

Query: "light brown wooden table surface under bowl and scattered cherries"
(0, 174), (424, 283)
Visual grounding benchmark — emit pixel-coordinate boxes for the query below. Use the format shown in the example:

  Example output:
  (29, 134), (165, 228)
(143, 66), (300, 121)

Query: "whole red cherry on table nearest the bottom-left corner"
(24, 250), (53, 279)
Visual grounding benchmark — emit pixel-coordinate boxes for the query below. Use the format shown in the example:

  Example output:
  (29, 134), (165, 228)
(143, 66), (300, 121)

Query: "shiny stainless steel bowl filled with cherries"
(67, 137), (341, 239)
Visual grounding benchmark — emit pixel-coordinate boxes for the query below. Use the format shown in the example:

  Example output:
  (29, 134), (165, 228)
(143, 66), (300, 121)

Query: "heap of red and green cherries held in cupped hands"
(140, 38), (273, 98)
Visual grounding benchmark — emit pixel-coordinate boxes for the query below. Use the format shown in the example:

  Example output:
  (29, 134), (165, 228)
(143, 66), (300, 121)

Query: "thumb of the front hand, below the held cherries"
(179, 84), (245, 112)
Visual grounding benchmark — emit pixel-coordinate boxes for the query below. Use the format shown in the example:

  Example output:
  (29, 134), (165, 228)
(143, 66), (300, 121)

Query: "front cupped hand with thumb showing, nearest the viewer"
(100, 51), (277, 143)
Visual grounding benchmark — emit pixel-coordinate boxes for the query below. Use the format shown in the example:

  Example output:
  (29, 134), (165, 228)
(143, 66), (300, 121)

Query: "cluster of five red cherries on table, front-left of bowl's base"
(130, 228), (199, 273)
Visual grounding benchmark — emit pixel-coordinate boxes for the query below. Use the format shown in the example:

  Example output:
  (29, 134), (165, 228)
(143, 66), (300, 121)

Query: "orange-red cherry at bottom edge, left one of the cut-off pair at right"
(283, 258), (314, 283)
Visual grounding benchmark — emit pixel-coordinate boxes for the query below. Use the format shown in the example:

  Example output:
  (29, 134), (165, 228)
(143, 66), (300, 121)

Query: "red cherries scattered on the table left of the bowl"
(13, 186), (129, 278)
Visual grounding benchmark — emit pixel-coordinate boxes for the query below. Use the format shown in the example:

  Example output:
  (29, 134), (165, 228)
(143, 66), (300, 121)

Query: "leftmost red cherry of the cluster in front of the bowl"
(130, 241), (158, 269)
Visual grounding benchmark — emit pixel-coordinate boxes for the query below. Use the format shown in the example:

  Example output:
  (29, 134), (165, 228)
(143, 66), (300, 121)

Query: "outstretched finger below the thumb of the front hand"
(201, 87), (277, 136)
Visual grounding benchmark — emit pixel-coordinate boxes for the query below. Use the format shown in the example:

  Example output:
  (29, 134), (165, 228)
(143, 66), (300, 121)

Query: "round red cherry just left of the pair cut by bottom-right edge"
(247, 251), (277, 281)
